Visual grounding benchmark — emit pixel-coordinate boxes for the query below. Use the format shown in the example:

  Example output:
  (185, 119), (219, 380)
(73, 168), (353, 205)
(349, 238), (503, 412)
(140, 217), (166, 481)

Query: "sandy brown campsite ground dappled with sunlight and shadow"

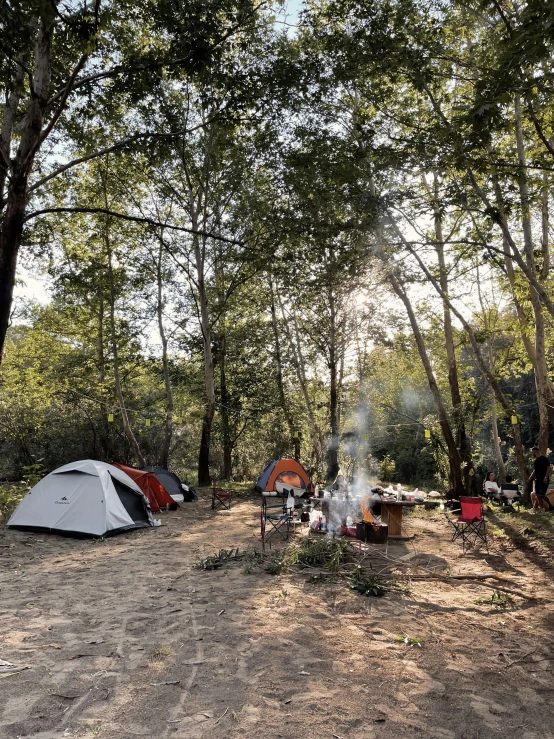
(0, 495), (554, 739)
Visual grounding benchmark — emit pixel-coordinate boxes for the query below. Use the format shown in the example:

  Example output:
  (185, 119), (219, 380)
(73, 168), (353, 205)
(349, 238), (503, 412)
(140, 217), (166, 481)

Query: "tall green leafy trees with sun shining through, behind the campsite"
(0, 0), (554, 493)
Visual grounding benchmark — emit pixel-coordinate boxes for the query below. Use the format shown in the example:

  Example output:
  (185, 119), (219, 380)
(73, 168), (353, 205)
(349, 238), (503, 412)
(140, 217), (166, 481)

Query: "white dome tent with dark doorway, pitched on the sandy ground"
(7, 459), (155, 537)
